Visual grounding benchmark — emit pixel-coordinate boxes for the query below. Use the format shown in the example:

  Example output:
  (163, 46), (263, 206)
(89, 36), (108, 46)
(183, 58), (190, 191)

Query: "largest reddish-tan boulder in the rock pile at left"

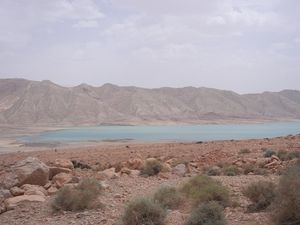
(12, 157), (49, 186)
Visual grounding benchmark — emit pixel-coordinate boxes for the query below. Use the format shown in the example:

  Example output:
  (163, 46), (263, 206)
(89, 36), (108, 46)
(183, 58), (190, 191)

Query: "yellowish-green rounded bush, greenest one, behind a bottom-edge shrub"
(181, 175), (229, 206)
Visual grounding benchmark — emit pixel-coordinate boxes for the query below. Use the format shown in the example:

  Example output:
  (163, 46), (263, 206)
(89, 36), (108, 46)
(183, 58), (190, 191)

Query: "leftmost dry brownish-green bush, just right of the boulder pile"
(51, 178), (102, 211)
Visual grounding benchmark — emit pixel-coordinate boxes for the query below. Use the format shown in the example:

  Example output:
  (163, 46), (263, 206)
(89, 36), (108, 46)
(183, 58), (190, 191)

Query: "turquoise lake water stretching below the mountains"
(21, 122), (300, 142)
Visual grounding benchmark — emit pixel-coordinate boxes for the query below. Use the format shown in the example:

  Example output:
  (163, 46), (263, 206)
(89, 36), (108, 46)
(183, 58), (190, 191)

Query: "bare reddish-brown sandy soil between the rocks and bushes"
(0, 135), (300, 225)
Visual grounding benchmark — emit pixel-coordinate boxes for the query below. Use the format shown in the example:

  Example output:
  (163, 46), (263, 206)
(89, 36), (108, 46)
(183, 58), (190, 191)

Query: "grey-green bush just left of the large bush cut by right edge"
(243, 181), (275, 212)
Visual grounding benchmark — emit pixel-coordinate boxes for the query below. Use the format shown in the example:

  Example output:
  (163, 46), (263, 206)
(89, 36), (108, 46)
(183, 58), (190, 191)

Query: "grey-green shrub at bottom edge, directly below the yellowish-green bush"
(184, 202), (227, 225)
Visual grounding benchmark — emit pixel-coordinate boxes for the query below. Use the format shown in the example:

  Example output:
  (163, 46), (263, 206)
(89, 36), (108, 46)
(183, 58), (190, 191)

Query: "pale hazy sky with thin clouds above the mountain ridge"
(0, 0), (300, 93)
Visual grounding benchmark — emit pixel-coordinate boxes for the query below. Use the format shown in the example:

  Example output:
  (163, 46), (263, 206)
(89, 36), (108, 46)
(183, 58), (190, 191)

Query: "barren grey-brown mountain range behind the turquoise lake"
(0, 79), (300, 125)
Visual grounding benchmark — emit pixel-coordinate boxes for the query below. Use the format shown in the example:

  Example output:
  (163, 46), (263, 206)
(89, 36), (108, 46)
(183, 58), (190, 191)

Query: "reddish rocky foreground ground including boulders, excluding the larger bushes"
(0, 135), (300, 225)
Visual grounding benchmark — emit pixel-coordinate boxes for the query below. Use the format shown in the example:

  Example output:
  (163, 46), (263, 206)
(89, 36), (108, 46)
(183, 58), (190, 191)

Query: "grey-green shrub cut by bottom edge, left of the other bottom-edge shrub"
(121, 198), (166, 225)
